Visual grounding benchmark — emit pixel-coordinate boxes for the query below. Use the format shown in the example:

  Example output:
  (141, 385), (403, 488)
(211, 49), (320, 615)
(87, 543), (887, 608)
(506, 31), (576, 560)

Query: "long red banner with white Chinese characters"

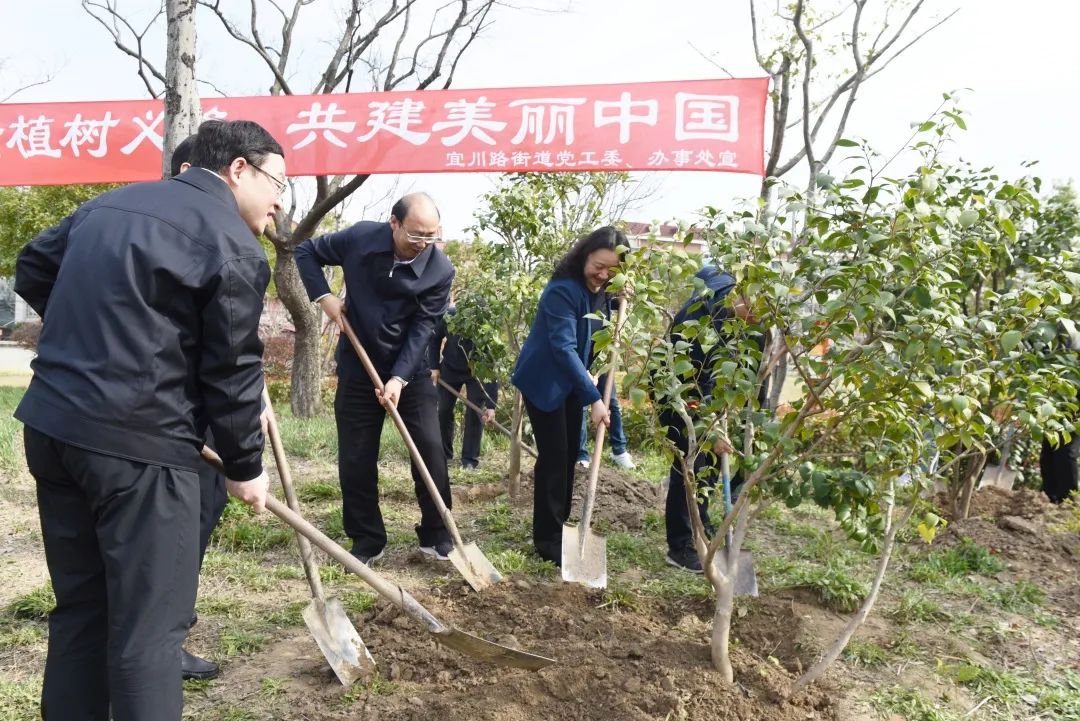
(0, 78), (769, 186)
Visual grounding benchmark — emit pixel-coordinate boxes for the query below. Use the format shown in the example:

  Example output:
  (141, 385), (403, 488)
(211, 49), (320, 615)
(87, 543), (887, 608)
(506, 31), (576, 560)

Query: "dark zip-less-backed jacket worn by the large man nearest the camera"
(15, 168), (270, 480)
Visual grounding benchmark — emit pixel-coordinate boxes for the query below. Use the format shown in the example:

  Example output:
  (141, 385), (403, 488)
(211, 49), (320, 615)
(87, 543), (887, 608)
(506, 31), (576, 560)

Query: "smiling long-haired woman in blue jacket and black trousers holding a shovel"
(511, 226), (627, 564)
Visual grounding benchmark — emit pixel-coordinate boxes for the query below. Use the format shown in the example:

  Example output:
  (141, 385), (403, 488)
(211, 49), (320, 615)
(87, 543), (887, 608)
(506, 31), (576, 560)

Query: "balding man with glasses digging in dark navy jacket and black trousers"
(294, 193), (454, 563)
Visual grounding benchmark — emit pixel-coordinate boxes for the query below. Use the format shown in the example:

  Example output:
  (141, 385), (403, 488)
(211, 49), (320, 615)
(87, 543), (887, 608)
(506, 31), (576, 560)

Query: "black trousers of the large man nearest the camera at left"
(24, 427), (200, 721)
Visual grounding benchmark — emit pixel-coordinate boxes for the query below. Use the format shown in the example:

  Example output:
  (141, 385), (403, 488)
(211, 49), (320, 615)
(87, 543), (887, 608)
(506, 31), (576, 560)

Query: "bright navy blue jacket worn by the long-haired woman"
(511, 278), (600, 412)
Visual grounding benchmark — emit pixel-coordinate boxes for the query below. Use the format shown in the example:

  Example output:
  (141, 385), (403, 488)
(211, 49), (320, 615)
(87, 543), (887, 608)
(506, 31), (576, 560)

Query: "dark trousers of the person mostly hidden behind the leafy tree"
(660, 410), (741, 550)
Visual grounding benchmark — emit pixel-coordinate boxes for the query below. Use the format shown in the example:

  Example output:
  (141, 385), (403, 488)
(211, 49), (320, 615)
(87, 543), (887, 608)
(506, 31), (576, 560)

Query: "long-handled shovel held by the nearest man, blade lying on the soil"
(203, 446), (555, 671)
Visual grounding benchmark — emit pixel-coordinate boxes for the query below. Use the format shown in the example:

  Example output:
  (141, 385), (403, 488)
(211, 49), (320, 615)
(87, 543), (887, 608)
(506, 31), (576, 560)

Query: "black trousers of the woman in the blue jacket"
(525, 394), (583, 563)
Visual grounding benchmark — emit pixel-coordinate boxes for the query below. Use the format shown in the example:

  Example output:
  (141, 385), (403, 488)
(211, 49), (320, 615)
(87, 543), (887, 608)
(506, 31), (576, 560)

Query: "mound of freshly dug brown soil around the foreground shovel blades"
(217, 579), (838, 721)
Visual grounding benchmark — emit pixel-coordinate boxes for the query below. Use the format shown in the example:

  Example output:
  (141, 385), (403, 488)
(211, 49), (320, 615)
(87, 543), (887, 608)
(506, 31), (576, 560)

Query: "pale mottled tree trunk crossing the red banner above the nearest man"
(161, 0), (202, 178)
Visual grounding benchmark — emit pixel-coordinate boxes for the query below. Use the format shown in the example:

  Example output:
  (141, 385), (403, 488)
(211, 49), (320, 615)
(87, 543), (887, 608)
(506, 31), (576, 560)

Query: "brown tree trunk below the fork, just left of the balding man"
(273, 246), (323, 418)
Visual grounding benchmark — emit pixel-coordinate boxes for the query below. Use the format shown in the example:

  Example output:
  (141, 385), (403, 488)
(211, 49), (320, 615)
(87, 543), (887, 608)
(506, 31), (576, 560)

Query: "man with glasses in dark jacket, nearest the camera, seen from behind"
(15, 121), (285, 721)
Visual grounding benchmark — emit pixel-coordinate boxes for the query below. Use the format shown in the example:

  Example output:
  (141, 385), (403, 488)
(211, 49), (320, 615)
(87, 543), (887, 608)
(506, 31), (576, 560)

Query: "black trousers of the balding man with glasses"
(334, 378), (453, 556)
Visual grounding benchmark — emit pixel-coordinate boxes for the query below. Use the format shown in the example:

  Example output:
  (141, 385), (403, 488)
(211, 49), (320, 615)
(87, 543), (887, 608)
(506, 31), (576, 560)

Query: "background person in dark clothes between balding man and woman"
(431, 305), (499, 468)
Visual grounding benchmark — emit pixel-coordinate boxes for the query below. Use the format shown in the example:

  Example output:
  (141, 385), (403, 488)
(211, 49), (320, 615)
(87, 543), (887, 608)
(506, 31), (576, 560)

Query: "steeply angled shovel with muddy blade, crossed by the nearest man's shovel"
(262, 387), (375, 686)
